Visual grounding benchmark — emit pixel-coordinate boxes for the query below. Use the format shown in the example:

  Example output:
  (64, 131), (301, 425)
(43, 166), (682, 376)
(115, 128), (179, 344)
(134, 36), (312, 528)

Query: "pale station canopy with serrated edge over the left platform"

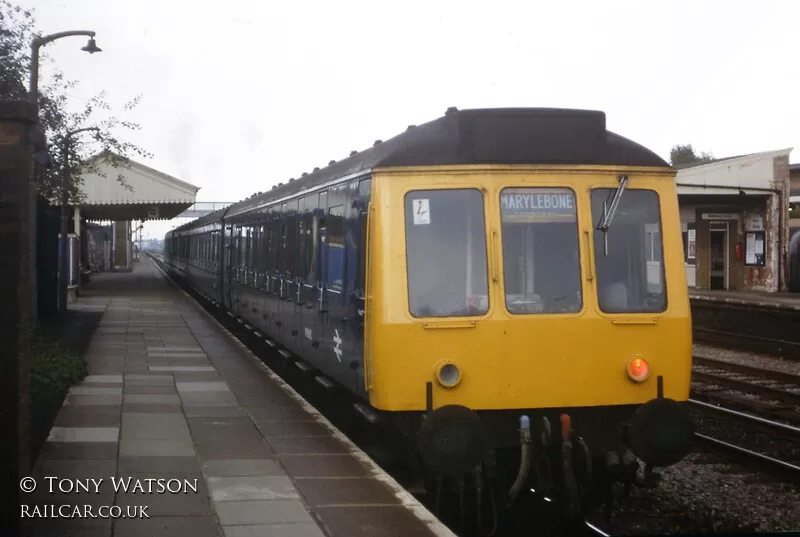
(72, 153), (200, 222)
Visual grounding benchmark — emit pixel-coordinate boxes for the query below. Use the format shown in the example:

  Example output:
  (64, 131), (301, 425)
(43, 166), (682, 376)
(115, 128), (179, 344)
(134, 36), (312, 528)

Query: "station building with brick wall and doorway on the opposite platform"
(676, 148), (800, 292)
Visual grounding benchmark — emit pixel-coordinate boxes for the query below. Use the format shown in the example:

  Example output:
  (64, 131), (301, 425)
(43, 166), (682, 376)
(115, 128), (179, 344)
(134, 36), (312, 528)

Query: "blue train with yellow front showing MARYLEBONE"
(163, 108), (694, 516)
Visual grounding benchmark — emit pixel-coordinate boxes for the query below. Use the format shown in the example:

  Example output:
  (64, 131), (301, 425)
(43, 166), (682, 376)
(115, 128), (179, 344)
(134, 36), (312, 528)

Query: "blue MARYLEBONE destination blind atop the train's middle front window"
(500, 188), (576, 222)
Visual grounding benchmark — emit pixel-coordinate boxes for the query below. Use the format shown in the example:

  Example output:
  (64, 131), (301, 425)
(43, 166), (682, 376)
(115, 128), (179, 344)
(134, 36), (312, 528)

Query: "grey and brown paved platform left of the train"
(23, 259), (455, 537)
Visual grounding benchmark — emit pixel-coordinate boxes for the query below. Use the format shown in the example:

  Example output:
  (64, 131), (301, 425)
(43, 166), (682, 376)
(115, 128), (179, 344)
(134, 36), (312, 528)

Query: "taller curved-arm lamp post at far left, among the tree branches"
(28, 30), (101, 322)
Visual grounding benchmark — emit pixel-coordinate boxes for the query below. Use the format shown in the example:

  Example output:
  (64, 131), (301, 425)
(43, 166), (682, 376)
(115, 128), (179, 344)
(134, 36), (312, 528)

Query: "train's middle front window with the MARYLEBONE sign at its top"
(500, 188), (583, 315)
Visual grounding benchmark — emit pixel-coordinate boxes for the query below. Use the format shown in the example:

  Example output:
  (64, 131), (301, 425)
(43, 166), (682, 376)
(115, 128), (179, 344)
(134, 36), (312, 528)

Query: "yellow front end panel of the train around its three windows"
(366, 166), (692, 411)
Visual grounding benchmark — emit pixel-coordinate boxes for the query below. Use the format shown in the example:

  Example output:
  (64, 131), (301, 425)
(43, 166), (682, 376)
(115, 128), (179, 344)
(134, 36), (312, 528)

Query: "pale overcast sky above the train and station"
(23, 0), (800, 237)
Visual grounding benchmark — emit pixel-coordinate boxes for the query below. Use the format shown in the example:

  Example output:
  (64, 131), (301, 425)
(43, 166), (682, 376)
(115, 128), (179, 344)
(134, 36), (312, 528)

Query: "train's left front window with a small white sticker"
(405, 189), (489, 317)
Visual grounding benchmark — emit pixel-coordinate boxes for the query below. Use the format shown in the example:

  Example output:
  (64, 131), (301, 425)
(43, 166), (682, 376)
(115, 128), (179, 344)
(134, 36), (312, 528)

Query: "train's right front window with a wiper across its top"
(592, 188), (667, 313)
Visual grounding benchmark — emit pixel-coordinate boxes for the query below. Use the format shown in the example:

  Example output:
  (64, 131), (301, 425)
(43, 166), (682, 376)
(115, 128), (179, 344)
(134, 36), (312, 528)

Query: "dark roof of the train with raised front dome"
(166, 108), (669, 231)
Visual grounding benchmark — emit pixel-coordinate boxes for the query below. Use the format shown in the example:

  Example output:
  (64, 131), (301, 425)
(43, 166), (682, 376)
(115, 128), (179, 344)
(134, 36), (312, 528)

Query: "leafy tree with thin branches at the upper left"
(0, 0), (151, 203)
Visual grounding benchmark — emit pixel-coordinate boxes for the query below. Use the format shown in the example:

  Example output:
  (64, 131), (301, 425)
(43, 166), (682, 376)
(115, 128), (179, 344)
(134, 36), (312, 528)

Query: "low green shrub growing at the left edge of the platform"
(23, 330), (88, 422)
